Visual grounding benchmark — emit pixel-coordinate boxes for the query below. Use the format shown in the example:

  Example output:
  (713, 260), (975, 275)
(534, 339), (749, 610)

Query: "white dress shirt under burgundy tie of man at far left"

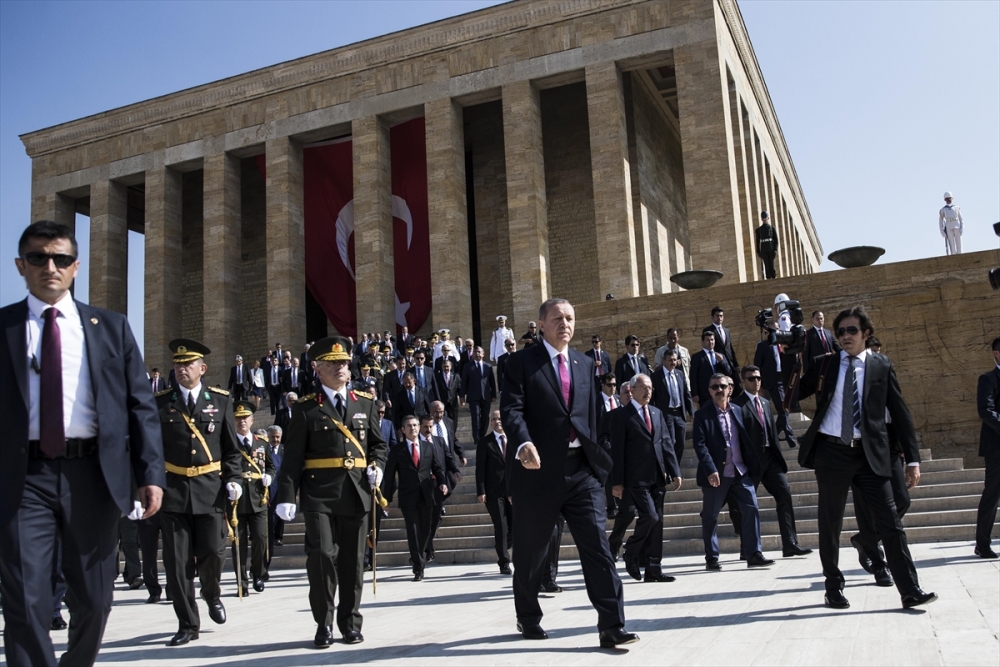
(25, 292), (97, 440)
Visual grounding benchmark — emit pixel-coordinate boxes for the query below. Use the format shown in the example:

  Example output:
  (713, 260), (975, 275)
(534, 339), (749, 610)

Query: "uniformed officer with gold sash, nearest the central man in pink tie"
(275, 336), (386, 648)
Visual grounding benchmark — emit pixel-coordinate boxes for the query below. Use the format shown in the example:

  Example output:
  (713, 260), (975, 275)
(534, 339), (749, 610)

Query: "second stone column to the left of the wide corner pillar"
(501, 81), (551, 327)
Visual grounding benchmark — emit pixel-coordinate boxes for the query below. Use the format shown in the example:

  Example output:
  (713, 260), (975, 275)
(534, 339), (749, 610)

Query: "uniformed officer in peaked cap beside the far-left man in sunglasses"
(156, 338), (242, 646)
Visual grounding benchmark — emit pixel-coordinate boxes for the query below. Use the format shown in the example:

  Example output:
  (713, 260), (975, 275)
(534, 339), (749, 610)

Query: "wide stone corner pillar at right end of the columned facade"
(674, 37), (747, 284)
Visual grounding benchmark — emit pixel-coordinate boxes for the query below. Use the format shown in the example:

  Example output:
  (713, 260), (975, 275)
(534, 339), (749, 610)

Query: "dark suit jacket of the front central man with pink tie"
(500, 343), (611, 499)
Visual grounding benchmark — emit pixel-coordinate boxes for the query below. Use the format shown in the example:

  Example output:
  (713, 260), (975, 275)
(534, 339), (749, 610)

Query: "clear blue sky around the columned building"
(0, 0), (1000, 352)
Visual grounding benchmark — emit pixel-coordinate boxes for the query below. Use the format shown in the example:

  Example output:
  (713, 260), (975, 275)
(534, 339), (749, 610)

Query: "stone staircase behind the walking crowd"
(262, 410), (996, 571)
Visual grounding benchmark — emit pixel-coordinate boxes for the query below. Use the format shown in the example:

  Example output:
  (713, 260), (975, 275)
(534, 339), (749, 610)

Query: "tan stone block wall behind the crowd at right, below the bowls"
(574, 251), (1000, 466)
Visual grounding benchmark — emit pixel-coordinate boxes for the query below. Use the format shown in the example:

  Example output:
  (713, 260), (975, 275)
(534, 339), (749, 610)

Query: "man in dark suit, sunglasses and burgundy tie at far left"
(0, 221), (166, 667)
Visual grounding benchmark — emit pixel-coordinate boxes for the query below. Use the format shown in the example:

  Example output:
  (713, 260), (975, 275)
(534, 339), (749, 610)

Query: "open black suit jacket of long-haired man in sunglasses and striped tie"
(799, 353), (920, 477)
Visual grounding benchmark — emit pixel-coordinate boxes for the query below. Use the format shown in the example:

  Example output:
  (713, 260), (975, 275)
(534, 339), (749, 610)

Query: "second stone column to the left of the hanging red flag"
(202, 153), (242, 386)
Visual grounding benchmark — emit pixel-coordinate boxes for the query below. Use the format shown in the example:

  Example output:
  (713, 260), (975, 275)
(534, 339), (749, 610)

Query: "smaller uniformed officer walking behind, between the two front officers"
(229, 401), (276, 595)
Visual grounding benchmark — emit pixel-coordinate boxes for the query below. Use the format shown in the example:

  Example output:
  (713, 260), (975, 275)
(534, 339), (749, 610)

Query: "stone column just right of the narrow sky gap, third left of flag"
(143, 167), (184, 377)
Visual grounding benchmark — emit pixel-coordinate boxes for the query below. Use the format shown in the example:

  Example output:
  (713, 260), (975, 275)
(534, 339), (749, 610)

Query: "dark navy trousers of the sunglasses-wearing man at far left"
(0, 456), (121, 667)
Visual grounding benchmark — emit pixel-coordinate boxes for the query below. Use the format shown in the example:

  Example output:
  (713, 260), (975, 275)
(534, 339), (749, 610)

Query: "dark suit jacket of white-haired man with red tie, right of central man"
(611, 403), (681, 488)
